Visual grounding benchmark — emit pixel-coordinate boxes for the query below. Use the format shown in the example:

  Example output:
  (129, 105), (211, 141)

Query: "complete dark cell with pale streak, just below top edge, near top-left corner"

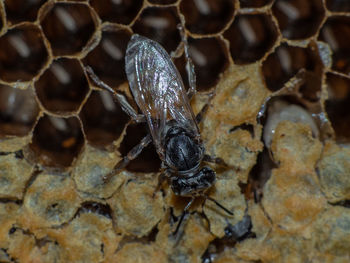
(40, 3), (95, 56)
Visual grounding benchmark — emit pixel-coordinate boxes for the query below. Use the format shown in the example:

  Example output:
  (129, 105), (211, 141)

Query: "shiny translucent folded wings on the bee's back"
(125, 35), (199, 159)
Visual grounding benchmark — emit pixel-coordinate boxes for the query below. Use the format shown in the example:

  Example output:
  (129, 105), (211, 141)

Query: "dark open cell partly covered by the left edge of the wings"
(83, 30), (131, 87)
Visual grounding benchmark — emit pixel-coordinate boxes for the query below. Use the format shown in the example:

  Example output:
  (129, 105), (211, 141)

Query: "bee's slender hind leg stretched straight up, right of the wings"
(177, 22), (196, 100)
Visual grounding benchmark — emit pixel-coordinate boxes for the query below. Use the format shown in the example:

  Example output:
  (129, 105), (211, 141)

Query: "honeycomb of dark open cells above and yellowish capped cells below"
(0, 0), (350, 263)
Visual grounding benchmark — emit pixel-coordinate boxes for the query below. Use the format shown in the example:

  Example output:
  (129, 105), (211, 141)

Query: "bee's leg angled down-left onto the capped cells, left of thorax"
(103, 134), (152, 183)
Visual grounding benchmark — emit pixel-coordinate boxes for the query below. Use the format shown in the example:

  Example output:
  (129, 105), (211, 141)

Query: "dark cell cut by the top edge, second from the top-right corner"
(272, 0), (325, 39)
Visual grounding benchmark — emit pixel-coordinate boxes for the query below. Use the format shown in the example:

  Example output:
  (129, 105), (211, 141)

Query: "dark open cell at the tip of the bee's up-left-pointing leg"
(35, 58), (89, 113)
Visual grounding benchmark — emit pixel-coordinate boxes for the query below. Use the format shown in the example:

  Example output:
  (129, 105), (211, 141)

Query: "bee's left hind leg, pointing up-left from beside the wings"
(84, 66), (145, 122)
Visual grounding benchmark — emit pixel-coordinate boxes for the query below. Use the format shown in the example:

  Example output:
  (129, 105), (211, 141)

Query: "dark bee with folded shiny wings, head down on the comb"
(86, 27), (233, 237)
